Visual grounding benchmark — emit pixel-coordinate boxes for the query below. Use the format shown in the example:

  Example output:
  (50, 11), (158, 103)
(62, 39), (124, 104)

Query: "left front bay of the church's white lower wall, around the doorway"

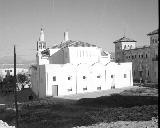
(46, 64), (76, 96)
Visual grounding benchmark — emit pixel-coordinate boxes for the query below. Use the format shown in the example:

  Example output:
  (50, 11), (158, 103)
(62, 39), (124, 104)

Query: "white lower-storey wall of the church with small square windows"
(32, 62), (133, 97)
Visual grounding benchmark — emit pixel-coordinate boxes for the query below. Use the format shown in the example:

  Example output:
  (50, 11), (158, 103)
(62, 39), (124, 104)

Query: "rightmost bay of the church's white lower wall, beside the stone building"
(106, 62), (133, 89)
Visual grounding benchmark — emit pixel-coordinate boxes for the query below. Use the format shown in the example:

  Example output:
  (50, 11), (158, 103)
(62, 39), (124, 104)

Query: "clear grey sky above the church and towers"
(0, 0), (159, 60)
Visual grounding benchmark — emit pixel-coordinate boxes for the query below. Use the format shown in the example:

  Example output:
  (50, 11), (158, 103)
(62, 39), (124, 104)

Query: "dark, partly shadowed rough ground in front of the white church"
(0, 87), (158, 128)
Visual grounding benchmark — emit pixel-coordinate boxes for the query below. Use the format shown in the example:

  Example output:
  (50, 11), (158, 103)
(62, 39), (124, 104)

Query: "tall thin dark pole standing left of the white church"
(14, 45), (19, 128)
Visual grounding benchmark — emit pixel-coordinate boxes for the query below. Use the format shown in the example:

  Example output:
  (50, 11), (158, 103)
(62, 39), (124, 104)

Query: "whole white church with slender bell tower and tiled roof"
(31, 29), (133, 98)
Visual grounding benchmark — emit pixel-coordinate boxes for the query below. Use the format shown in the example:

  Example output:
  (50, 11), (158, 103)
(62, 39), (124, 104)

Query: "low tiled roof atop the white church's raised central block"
(52, 40), (97, 49)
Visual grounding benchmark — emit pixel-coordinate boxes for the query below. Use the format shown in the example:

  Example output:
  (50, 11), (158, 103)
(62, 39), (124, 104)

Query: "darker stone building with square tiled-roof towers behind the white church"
(113, 29), (159, 83)
